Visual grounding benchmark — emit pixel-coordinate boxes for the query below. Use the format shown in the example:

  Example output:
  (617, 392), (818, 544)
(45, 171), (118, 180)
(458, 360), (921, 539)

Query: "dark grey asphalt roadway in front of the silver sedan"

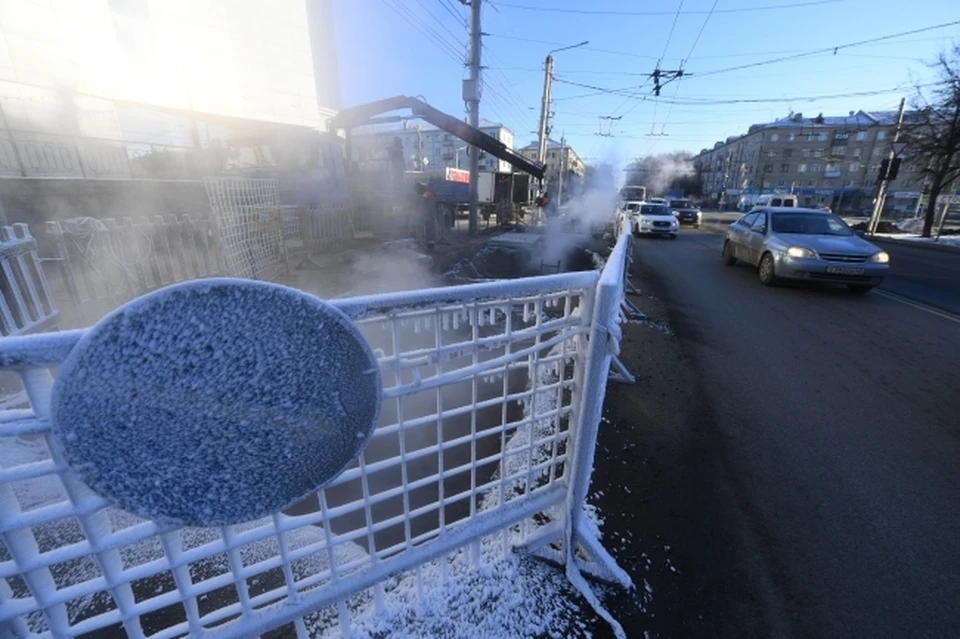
(613, 227), (960, 638)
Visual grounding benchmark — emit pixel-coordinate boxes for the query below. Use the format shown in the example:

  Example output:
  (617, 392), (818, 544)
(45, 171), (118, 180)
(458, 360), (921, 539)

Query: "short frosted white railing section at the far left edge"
(0, 224), (60, 336)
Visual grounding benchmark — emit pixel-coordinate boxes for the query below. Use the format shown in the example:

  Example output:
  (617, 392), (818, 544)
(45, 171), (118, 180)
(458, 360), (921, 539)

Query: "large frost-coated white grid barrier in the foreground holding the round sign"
(0, 232), (631, 638)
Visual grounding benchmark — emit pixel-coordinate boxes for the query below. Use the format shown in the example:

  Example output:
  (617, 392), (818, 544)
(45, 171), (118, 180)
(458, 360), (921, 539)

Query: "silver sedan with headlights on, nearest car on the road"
(723, 207), (890, 293)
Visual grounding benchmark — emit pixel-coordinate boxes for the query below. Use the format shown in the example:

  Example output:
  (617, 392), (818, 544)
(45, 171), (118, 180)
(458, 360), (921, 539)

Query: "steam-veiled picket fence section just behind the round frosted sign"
(47, 215), (228, 324)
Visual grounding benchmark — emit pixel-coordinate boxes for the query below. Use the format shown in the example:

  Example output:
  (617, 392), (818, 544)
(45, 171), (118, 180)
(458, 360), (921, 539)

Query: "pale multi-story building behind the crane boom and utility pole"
(351, 120), (514, 173)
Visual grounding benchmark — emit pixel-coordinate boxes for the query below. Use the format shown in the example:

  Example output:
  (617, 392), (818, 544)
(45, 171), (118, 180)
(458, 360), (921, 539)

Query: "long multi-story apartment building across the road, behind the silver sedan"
(693, 111), (924, 212)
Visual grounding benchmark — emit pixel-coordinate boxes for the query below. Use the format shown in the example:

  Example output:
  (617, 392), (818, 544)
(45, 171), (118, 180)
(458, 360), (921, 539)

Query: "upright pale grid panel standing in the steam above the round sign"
(204, 177), (289, 279)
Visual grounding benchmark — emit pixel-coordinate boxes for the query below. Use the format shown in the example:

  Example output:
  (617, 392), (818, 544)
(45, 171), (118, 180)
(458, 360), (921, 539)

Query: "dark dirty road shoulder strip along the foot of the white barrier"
(591, 262), (776, 637)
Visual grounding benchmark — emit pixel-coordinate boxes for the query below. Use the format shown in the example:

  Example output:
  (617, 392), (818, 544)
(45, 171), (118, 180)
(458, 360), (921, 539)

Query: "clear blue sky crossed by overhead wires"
(333, 0), (960, 169)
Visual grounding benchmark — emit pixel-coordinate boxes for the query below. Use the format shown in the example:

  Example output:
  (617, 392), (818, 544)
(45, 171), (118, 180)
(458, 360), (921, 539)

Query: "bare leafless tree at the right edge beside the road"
(906, 45), (960, 237)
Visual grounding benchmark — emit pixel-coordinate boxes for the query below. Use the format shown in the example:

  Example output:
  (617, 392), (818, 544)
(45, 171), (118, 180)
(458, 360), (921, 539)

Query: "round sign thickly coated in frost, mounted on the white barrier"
(51, 279), (382, 526)
